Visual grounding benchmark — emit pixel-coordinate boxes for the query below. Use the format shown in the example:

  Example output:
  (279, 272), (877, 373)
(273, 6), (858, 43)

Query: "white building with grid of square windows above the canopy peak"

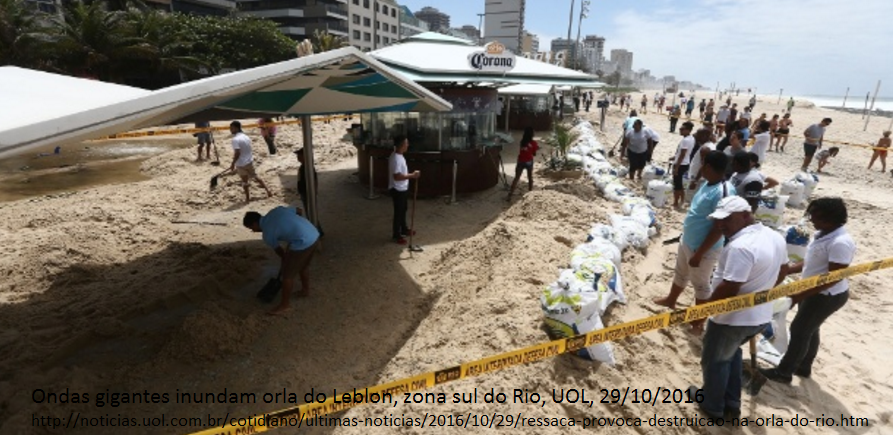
(348, 0), (400, 51)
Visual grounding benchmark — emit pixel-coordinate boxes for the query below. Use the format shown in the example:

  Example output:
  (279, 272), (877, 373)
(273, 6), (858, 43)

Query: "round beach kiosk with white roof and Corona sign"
(353, 32), (599, 196)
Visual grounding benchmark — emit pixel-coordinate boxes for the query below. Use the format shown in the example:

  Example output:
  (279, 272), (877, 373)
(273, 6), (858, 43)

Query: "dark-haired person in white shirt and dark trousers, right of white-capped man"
(761, 198), (857, 384)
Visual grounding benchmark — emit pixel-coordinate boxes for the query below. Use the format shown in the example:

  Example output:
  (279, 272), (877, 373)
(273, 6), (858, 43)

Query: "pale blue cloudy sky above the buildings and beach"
(398, 0), (894, 99)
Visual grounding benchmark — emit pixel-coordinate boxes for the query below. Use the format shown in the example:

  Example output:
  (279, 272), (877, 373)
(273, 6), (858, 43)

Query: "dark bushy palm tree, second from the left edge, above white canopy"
(55, 1), (153, 83)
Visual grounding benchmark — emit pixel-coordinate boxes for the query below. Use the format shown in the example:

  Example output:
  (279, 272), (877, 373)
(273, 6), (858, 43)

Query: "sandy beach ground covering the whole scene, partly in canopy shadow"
(0, 90), (894, 434)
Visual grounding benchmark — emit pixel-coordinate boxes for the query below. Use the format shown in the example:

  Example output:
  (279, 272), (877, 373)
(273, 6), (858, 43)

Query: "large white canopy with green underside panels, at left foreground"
(0, 47), (452, 157)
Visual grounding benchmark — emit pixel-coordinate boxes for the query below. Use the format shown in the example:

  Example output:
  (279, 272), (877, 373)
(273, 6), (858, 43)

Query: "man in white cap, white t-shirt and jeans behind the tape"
(691, 196), (788, 418)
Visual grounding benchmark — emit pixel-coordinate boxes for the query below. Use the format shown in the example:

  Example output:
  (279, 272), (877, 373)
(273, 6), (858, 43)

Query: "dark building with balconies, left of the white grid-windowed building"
(238, 0), (348, 41)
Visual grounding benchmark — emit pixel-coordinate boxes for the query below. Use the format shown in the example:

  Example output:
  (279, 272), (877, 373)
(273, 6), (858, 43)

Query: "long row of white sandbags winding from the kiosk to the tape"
(540, 121), (664, 364)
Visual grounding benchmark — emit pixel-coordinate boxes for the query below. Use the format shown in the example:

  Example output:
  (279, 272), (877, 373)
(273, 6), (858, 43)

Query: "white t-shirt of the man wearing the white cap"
(711, 223), (788, 326)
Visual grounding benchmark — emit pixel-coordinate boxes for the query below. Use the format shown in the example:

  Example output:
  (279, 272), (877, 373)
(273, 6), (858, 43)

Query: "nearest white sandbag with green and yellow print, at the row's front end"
(540, 271), (615, 365)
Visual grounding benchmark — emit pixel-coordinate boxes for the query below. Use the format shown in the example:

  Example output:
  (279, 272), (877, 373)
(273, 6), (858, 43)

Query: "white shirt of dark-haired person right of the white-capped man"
(801, 227), (857, 296)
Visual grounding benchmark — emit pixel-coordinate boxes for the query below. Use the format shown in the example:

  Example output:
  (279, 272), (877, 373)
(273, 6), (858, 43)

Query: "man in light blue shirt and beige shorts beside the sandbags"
(652, 151), (736, 332)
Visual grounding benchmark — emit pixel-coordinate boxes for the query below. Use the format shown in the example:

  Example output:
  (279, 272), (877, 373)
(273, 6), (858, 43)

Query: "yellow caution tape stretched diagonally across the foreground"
(191, 257), (894, 435)
